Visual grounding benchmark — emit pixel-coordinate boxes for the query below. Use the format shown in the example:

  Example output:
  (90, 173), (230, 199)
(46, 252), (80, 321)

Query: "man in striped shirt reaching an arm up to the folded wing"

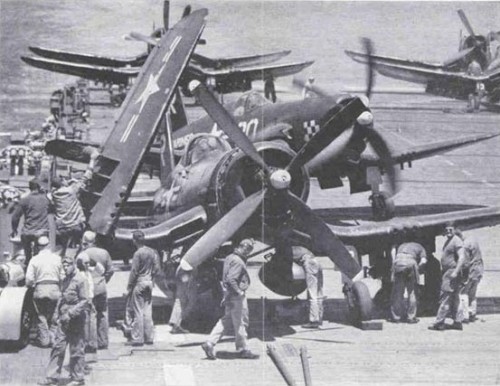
(51, 150), (99, 256)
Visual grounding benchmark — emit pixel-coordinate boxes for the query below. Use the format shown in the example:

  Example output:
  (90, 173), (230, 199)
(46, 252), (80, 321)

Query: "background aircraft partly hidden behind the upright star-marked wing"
(21, 1), (313, 96)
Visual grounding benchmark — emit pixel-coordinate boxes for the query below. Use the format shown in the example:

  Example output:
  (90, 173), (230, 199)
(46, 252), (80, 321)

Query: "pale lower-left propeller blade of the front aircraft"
(178, 189), (266, 271)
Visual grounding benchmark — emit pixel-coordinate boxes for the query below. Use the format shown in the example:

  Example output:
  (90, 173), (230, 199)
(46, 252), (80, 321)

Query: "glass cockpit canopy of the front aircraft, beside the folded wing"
(180, 133), (231, 166)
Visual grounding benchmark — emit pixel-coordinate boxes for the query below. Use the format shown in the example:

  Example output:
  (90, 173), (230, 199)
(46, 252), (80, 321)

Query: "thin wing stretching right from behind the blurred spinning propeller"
(361, 134), (500, 166)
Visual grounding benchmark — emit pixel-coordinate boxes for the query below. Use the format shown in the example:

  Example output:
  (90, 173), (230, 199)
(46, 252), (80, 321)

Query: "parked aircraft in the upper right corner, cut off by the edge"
(345, 10), (500, 110)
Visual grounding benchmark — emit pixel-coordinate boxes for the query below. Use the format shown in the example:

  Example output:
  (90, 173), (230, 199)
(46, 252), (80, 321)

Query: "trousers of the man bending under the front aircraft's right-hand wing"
(391, 267), (417, 320)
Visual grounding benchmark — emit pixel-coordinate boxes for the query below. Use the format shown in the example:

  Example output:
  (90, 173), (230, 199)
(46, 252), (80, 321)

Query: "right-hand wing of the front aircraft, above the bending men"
(326, 205), (500, 253)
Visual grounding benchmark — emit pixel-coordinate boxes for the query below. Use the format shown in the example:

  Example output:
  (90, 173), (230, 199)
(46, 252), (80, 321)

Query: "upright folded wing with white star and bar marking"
(87, 9), (208, 234)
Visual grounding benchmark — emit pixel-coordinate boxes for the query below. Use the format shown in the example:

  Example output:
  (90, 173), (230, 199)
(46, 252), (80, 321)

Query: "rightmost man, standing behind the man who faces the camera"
(455, 228), (484, 323)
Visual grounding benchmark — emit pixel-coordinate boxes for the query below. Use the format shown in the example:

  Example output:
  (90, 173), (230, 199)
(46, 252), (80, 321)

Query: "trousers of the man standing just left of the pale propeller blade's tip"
(131, 281), (154, 343)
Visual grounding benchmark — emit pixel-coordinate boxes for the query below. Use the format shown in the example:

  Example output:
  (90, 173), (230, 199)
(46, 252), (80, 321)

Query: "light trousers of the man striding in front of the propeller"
(208, 295), (248, 351)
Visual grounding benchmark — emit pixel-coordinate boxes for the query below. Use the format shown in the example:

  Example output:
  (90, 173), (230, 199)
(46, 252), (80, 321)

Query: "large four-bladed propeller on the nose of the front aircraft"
(175, 82), (367, 278)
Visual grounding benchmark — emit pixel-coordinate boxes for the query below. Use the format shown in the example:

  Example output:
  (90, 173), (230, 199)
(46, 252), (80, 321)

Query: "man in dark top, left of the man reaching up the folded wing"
(11, 179), (50, 264)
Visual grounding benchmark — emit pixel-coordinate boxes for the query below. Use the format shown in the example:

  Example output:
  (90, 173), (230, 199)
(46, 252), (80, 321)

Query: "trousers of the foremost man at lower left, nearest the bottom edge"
(47, 315), (85, 381)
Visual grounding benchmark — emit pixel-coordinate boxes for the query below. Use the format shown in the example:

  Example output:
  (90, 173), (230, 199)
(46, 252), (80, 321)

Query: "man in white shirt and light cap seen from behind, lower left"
(26, 236), (64, 347)
